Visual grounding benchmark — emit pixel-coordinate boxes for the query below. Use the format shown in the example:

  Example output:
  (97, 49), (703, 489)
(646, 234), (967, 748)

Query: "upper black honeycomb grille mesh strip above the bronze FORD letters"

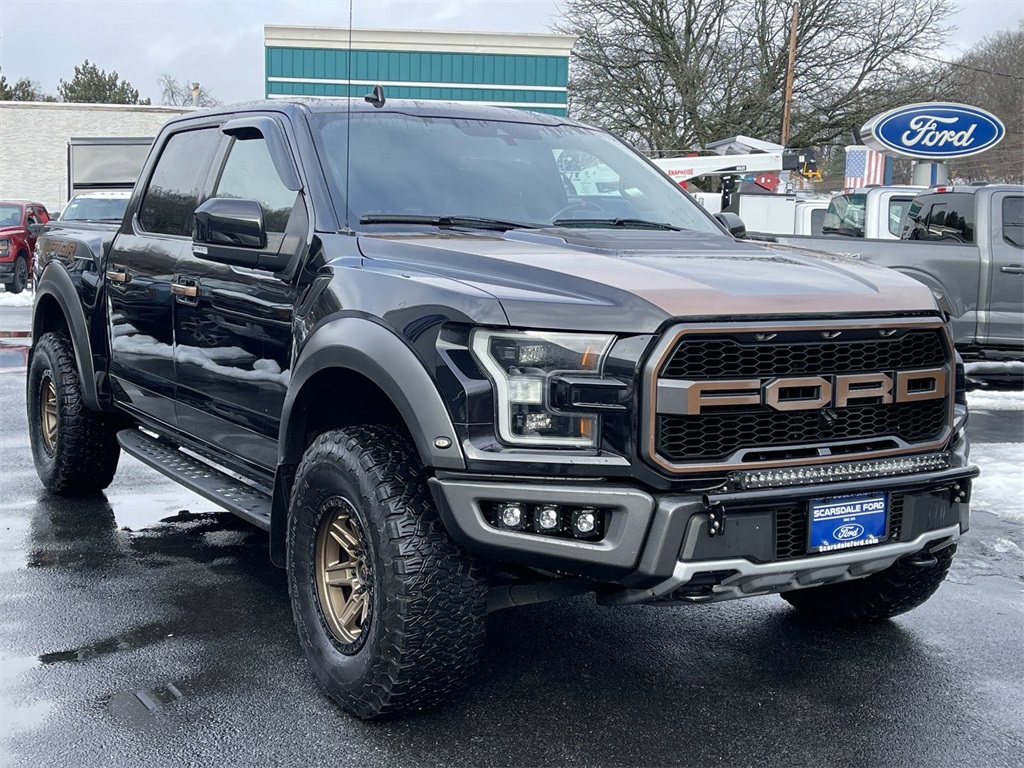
(660, 329), (946, 380)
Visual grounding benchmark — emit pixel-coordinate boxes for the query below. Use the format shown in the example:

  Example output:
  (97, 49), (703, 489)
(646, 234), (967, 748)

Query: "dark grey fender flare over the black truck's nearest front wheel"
(278, 315), (466, 470)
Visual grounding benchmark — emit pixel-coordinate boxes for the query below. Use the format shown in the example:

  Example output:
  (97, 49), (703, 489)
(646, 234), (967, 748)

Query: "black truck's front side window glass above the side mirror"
(213, 138), (298, 232)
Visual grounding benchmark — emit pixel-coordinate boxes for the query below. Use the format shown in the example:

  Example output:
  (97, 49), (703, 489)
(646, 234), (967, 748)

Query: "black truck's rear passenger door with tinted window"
(105, 126), (221, 426)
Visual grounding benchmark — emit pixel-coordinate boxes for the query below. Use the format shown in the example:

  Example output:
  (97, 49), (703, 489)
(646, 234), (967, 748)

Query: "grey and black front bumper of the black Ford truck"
(430, 440), (978, 603)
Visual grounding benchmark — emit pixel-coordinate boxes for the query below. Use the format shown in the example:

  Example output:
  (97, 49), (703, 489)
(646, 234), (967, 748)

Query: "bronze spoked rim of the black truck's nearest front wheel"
(313, 498), (373, 645)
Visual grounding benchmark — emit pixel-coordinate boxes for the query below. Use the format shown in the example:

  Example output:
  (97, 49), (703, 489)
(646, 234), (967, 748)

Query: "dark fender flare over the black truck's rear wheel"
(30, 264), (101, 411)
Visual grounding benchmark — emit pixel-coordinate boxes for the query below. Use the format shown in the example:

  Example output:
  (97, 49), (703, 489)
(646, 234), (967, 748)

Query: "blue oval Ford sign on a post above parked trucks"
(860, 102), (1006, 160)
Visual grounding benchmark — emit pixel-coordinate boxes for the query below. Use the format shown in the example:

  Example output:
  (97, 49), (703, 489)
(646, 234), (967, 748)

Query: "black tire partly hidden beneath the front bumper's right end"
(782, 544), (956, 625)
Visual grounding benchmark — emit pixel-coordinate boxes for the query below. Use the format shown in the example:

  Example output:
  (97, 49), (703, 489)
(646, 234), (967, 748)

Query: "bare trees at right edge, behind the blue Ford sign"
(949, 22), (1024, 184)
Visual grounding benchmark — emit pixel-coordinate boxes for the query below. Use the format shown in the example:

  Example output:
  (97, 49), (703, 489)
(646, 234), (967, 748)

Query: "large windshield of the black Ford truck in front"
(317, 113), (721, 233)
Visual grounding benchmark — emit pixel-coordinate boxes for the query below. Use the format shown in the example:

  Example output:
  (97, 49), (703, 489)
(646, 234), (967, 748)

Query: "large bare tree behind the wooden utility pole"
(556, 0), (951, 152)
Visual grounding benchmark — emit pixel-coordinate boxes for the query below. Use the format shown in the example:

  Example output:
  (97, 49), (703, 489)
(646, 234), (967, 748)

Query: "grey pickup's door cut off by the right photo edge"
(982, 191), (1024, 344)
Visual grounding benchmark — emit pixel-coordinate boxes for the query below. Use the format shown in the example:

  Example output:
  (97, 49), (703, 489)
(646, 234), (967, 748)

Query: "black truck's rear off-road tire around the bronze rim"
(26, 332), (121, 496)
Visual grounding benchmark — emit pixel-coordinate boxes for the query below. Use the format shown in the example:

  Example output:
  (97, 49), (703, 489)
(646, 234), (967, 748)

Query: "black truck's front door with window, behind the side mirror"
(174, 121), (309, 469)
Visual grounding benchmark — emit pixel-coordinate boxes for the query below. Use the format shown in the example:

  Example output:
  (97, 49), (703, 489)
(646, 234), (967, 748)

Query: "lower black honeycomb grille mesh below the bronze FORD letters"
(656, 399), (948, 464)
